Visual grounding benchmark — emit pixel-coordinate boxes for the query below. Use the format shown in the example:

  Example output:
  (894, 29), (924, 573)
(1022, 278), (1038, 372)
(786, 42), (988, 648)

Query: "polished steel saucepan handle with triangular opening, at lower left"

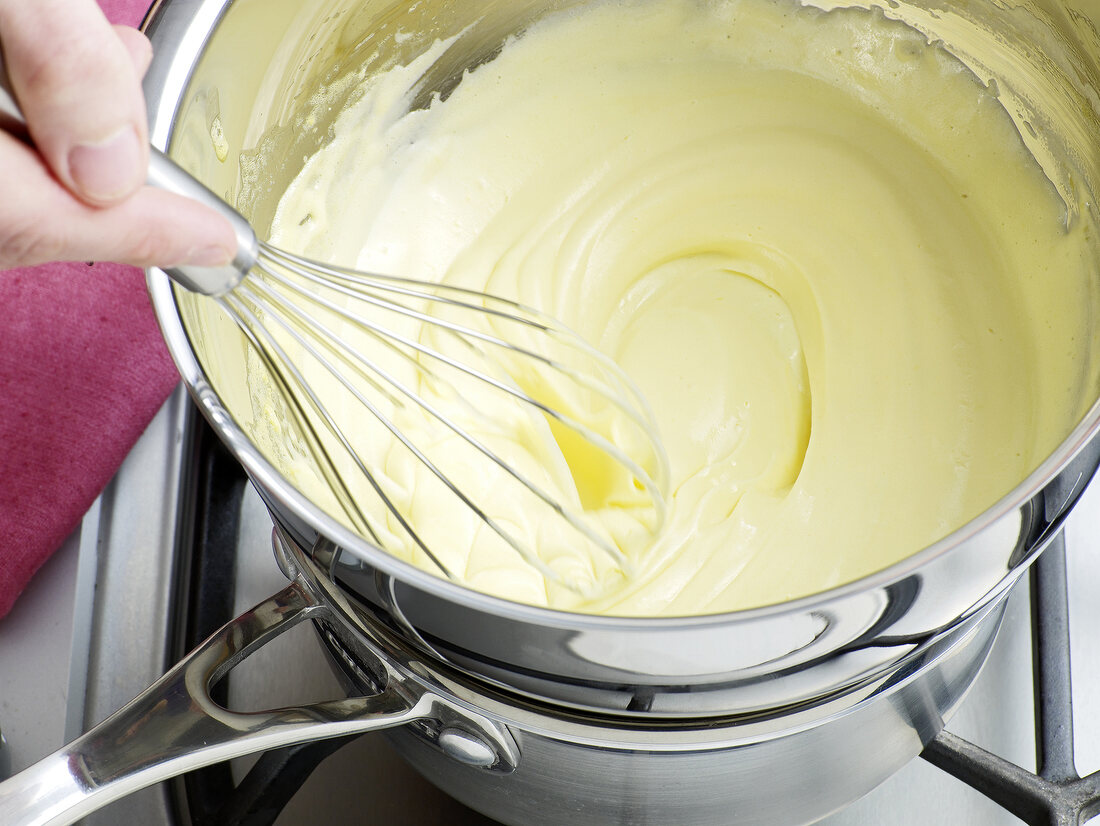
(0, 583), (438, 826)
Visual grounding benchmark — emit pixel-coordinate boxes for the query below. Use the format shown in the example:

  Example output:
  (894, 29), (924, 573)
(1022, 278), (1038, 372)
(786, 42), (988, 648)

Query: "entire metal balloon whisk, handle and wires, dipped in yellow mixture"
(0, 46), (667, 595)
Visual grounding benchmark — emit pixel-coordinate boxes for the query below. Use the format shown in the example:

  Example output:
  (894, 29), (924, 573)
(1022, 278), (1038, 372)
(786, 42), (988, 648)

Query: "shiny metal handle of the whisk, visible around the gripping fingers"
(0, 48), (260, 296)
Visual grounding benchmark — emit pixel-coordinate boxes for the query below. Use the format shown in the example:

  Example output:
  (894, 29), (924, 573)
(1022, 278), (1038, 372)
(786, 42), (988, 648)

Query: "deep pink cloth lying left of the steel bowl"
(0, 0), (173, 617)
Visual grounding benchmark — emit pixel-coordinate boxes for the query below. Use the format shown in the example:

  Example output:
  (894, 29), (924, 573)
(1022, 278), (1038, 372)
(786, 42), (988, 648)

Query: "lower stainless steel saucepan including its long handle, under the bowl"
(0, 532), (1004, 826)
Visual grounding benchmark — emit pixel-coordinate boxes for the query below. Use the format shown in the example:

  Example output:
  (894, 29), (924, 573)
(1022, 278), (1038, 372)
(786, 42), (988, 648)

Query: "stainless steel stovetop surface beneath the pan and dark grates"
(0, 392), (1100, 826)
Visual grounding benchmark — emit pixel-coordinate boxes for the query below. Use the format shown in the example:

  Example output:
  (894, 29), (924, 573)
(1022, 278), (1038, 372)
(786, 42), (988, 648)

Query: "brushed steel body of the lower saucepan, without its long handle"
(294, 530), (1005, 826)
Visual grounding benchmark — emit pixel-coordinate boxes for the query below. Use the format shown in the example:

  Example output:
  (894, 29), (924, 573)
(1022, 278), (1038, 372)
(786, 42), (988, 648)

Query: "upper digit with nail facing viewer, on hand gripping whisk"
(0, 0), (149, 206)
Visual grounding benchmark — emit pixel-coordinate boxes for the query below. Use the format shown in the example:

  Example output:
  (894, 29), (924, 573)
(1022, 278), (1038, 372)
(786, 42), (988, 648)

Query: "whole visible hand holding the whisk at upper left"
(0, 0), (235, 268)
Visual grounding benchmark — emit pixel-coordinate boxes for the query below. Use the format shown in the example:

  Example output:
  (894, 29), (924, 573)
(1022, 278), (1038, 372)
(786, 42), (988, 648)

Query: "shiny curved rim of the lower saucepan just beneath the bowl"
(305, 519), (1008, 750)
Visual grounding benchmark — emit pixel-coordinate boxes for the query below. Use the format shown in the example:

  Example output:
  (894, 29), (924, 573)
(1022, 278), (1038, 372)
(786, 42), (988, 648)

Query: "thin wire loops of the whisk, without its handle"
(204, 244), (667, 596)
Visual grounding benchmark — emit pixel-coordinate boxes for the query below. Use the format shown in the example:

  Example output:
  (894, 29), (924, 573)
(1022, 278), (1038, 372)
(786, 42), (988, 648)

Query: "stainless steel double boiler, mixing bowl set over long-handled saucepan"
(0, 0), (1100, 826)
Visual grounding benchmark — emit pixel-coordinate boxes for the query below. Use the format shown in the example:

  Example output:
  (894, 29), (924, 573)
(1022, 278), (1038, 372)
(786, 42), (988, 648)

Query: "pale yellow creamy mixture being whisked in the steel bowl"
(227, 0), (1096, 616)
